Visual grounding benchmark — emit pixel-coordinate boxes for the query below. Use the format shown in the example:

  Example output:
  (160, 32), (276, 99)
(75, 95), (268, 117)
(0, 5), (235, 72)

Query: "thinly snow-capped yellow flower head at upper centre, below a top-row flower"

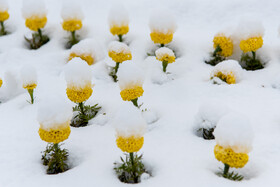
(108, 41), (132, 63)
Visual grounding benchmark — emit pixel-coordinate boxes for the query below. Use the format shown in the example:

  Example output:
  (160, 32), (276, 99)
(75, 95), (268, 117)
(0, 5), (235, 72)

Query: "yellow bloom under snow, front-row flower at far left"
(38, 121), (71, 144)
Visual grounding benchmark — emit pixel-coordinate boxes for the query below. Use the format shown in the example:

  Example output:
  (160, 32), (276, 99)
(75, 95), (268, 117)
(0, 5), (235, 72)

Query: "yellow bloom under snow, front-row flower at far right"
(214, 145), (249, 168)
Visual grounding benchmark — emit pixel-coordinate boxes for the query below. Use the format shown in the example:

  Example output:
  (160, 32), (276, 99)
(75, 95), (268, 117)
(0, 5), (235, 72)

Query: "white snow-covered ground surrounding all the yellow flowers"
(0, 0), (280, 187)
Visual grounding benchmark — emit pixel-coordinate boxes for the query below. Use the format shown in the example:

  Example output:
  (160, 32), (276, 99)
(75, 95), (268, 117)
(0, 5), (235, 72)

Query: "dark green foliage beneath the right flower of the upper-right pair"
(241, 52), (264, 70)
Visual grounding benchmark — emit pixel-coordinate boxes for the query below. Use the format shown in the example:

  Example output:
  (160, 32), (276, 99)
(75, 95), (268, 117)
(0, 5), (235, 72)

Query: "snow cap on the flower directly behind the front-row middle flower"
(117, 61), (145, 90)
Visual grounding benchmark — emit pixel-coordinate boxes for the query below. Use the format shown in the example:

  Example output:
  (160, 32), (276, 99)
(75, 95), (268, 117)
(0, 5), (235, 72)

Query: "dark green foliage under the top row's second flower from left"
(24, 29), (50, 49)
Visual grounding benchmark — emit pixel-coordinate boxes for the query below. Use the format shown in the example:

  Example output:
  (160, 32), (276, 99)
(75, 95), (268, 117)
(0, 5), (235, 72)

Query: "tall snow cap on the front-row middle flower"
(114, 104), (147, 137)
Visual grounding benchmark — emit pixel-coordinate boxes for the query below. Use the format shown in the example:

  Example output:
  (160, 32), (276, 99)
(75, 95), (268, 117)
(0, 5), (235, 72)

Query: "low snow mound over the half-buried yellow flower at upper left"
(70, 39), (104, 62)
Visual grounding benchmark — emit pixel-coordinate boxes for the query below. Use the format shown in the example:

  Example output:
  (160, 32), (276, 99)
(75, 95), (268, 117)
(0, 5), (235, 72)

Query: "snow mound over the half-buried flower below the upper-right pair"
(211, 60), (243, 82)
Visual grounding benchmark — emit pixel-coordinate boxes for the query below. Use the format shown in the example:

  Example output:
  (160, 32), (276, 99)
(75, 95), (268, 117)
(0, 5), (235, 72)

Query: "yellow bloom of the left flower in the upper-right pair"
(213, 34), (233, 57)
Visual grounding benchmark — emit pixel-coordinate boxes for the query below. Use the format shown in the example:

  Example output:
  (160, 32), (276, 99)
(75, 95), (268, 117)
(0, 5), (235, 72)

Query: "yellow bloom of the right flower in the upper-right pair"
(239, 36), (263, 53)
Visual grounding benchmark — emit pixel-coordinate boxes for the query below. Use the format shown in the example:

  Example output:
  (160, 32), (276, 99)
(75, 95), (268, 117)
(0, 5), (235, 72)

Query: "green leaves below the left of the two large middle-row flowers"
(70, 103), (101, 127)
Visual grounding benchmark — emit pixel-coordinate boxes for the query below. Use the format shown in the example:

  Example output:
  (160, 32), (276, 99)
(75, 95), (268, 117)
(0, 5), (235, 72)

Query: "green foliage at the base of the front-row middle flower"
(114, 153), (147, 184)
